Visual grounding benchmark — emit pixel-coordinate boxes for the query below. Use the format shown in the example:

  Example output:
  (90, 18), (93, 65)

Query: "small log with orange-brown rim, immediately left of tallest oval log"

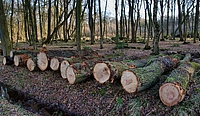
(26, 57), (37, 71)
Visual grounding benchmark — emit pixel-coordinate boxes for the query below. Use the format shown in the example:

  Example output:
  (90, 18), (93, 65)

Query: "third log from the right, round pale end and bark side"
(93, 62), (129, 83)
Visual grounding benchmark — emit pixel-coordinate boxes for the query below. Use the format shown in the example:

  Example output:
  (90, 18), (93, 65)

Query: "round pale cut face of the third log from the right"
(93, 63), (110, 83)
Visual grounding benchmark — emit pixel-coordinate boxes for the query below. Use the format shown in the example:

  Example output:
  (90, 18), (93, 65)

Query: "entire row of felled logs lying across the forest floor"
(3, 50), (200, 106)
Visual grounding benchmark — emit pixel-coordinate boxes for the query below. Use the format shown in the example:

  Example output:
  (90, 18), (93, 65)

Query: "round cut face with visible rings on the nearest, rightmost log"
(159, 83), (183, 106)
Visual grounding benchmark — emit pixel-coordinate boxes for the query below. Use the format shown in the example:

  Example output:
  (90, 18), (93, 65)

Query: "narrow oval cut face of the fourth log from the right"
(66, 65), (76, 84)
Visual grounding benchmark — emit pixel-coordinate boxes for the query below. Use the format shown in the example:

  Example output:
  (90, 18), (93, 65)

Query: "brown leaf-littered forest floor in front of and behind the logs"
(0, 40), (200, 116)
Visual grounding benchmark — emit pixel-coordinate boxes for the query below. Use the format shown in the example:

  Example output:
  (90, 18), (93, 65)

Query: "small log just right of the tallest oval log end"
(50, 57), (64, 71)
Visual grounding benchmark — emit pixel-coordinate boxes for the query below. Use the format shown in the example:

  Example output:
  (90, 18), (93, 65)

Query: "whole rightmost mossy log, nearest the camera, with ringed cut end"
(159, 54), (200, 106)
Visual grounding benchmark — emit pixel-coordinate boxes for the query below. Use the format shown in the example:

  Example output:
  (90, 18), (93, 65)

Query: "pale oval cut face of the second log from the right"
(121, 70), (138, 93)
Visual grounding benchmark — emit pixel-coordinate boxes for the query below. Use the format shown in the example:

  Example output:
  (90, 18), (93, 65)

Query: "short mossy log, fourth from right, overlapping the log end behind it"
(66, 62), (91, 84)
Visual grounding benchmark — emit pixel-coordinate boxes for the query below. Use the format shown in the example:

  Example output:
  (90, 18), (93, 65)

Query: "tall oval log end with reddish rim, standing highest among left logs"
(37, 52), (49, 71)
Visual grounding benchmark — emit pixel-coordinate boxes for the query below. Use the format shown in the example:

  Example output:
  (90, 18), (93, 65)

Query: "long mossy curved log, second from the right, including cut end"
(121, 56), (178, 93)
